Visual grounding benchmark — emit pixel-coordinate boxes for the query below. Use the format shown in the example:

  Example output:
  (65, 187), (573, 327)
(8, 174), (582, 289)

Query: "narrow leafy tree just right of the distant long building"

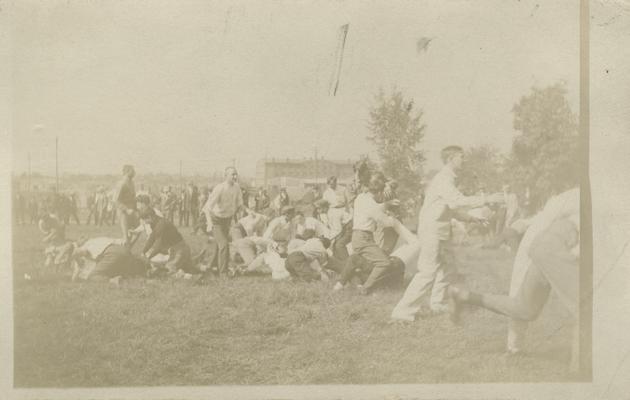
(367, 90), (426, 200)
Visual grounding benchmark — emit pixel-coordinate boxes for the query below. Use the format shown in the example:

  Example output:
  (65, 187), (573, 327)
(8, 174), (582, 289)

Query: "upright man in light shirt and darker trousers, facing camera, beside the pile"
(203, 167), (243, 274)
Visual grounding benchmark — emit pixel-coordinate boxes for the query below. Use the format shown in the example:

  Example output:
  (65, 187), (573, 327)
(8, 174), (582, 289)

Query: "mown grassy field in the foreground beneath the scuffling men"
(13, 220), (571, 387)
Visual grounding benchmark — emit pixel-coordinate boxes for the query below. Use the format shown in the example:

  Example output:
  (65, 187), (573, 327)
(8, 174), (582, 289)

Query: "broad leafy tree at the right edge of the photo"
(506, 83), (579, 206)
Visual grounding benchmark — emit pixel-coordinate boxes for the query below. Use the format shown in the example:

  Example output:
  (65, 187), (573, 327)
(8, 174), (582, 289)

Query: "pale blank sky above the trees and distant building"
(11, 0), (579, 175)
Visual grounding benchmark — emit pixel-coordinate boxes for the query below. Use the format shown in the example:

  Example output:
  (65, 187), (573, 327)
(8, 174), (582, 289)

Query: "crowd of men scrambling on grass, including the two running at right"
(27, 146), (579, 374)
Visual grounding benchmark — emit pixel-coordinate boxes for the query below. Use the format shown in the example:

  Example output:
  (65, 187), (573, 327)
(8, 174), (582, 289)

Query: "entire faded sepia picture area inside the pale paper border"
(0, 0), (630, 398)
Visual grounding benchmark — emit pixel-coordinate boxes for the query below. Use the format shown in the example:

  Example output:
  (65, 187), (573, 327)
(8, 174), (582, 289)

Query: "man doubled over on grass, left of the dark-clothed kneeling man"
(72, 237), (150, 284)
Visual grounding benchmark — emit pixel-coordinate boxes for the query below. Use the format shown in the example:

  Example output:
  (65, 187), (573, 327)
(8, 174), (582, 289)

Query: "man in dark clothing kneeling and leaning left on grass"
(140, 208), (195, 274)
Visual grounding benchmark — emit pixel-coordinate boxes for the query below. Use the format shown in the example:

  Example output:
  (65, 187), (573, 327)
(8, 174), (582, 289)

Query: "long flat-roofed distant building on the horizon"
(255, 158), (354, 186)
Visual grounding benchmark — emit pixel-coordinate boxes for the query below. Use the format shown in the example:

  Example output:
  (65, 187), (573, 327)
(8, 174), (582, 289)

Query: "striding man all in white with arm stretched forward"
(391, 146), (503, 321)
